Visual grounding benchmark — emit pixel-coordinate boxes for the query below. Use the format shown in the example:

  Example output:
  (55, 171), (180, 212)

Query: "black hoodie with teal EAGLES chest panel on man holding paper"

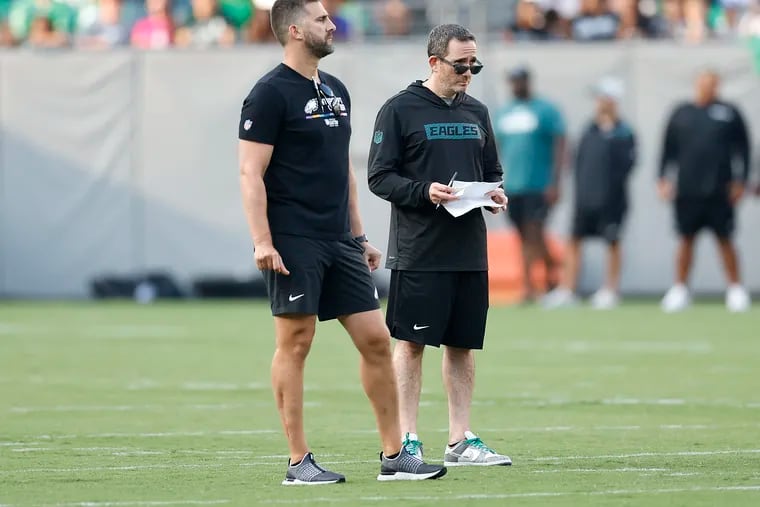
(368, 81), (502, 271)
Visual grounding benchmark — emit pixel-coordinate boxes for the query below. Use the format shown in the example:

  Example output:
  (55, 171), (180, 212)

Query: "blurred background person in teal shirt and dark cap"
(494, 67), (565, 301)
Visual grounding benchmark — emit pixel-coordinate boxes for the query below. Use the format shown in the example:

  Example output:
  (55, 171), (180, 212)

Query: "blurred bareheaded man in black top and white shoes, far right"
(658, 70), (751, 312)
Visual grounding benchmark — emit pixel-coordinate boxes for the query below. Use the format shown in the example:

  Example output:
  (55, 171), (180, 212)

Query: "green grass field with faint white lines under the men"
(0, 303), (760, 507)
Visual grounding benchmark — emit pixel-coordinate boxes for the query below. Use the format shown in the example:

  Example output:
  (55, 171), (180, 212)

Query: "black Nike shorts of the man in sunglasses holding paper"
(385, 270), (488, 349)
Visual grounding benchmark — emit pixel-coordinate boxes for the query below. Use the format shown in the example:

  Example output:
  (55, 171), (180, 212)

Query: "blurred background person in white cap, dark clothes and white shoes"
(543, 78), (636, 310)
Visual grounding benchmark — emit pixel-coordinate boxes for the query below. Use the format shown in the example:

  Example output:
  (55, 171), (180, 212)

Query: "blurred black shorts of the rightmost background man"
(675, 196), (735, 238)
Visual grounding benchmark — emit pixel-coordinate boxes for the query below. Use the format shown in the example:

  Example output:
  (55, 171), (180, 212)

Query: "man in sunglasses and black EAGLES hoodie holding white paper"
(369, 25), (512, 466)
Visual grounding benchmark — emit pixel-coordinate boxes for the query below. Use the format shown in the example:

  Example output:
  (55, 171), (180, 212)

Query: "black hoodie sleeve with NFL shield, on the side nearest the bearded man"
(367, 103), (430, 208)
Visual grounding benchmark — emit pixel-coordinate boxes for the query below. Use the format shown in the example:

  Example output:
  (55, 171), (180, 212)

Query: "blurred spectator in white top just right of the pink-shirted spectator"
(175, 0), (235, 48)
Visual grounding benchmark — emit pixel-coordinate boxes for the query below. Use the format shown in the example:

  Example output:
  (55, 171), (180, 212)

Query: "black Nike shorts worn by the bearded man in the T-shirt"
(262, 235), (380, 320)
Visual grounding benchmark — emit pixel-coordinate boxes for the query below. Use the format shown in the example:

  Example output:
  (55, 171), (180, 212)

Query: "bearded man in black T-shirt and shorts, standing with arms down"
(238, 0), (446, 485)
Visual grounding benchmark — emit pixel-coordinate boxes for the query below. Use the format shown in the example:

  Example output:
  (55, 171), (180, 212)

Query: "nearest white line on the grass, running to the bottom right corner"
(259, 485), (760, 504)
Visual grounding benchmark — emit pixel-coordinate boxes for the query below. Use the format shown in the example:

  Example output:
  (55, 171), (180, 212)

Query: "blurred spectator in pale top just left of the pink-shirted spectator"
(76, 0), (129, 49)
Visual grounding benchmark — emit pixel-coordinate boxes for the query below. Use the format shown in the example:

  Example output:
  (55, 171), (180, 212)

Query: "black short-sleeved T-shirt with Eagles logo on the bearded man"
(238, 64), (351, 240)
